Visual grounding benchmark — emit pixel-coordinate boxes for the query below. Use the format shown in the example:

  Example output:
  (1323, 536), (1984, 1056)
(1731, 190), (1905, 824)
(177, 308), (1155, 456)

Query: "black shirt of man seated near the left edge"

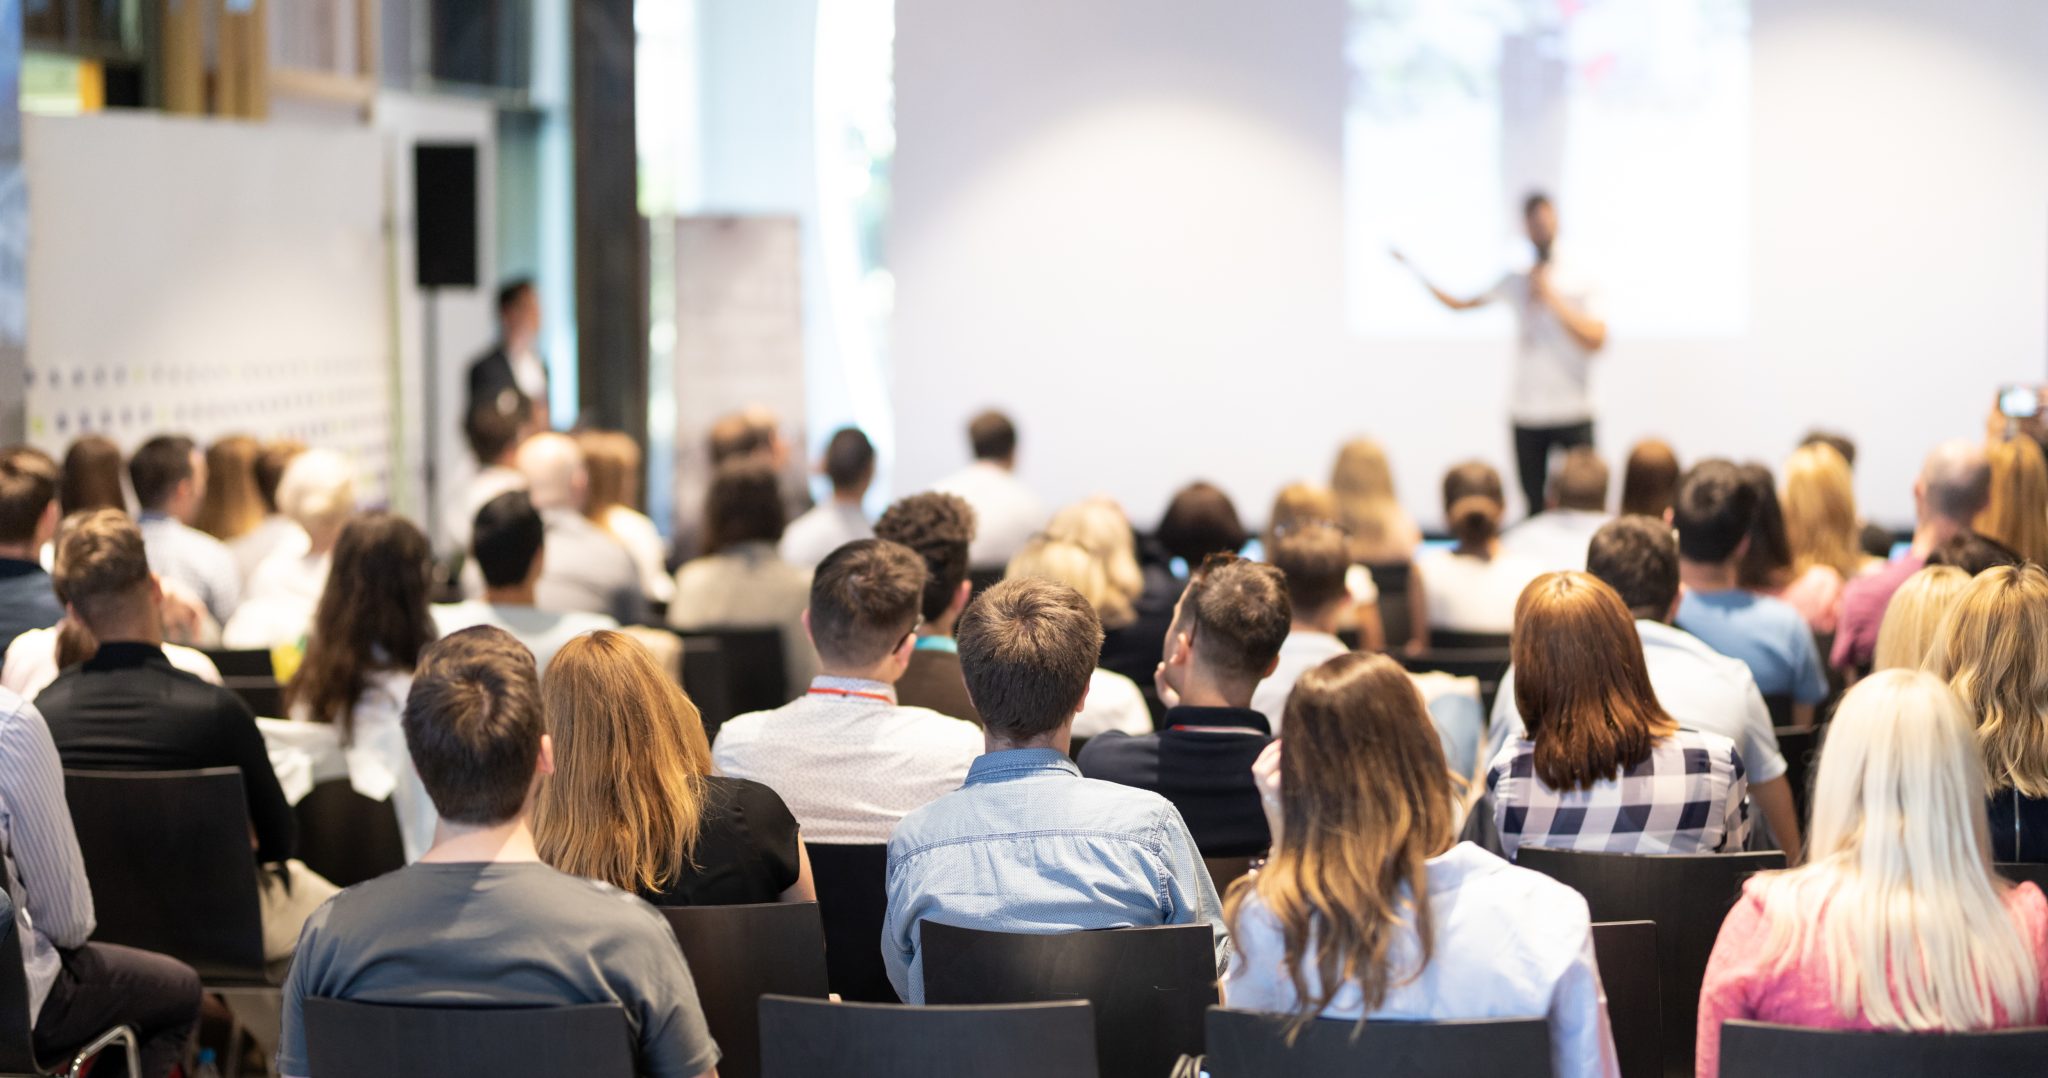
(35, 641), (293, 861)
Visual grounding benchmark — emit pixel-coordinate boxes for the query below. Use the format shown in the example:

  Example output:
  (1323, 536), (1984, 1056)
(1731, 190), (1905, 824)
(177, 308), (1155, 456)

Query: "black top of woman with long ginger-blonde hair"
(641, 775), (803, 906)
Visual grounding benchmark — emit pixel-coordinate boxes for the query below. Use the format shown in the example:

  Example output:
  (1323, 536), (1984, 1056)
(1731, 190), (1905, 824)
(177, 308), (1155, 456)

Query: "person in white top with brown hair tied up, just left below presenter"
(1415, 461), (1542, 635)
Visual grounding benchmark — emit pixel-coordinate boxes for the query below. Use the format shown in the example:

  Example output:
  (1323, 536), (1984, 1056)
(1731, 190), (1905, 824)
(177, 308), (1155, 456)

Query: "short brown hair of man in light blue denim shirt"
(954, 576), (1102, 742)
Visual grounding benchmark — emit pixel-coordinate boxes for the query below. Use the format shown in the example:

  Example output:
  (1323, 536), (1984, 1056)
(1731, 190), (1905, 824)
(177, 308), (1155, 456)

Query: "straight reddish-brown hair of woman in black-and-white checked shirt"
(1513, 572), (1677, 791)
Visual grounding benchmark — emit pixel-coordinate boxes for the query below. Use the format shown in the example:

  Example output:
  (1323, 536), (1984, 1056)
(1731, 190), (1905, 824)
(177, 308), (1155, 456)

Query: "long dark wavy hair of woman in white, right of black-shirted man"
(285, 512), (434, 744)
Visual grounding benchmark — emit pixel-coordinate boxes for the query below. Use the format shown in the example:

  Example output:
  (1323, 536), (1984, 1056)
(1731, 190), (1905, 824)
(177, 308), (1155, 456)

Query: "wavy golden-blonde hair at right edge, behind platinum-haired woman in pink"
(1925, 566), (2048, 797)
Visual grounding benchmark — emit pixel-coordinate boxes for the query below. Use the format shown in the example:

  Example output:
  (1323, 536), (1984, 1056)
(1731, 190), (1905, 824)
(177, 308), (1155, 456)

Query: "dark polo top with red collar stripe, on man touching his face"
(1077, 707), (1272, 857)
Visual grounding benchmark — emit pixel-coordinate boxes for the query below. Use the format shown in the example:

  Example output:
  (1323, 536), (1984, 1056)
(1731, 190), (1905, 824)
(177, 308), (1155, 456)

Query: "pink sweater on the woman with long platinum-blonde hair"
(1694, 883), (2048, 1078)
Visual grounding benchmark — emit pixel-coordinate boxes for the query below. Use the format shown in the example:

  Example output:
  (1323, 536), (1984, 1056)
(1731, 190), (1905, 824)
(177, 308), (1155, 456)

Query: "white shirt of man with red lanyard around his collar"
(711, 676), (983, 846)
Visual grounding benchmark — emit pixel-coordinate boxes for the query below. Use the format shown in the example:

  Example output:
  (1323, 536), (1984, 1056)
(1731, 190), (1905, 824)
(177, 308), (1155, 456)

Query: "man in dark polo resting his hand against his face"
(1081, 553), (1292, 857)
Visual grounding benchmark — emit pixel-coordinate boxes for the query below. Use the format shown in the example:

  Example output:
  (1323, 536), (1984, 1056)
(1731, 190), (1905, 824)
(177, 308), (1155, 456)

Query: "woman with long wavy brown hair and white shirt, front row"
(1223, 652), (1616, 1078)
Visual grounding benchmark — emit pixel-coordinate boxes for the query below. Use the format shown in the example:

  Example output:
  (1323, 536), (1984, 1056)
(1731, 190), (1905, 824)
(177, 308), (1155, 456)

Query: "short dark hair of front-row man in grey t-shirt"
(403, 625), (547, 826)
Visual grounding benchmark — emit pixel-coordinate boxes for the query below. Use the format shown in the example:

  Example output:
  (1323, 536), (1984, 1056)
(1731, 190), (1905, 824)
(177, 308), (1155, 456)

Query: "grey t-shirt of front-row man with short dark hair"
(276, 863), (719, 1078)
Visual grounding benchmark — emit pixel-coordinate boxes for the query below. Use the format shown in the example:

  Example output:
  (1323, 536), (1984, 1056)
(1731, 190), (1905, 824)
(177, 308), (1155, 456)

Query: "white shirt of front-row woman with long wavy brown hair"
(1223, 842), (1620, 1078)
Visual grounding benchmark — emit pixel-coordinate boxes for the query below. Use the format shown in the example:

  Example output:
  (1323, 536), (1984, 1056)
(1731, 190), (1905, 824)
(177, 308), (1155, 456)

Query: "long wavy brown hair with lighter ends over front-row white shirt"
(1223, 652), (1458, 1035)
